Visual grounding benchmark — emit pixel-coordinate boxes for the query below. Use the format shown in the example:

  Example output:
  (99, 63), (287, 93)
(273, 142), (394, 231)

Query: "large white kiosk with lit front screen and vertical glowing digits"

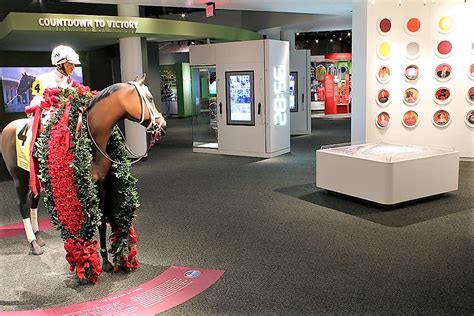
(189, 40), (290, 158)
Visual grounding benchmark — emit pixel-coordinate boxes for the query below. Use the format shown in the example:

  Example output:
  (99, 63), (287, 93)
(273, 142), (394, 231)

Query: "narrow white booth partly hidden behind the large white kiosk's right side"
(289, 49), (311, 135)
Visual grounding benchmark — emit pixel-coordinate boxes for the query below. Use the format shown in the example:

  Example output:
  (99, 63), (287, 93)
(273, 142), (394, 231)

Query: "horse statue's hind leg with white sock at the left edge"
(2, 121), (43, 255)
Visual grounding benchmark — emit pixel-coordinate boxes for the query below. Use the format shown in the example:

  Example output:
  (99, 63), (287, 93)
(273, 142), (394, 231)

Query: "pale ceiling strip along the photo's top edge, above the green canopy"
(62, 0), (354, 15)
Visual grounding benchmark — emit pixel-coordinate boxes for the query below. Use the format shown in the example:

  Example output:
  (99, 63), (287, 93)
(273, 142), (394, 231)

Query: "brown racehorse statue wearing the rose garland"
(0, 75), (167, 278)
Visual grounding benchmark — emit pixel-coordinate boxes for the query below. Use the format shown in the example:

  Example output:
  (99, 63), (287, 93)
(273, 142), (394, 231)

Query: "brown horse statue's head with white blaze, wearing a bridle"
(129, 74), (167, 141)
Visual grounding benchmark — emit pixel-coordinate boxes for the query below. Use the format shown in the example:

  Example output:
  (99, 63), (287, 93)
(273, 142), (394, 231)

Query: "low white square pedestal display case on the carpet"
(316, 143), (459, 205)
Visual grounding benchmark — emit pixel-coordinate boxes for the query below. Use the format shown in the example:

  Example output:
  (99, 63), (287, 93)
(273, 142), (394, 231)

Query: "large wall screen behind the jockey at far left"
(0, 67), (83, 113)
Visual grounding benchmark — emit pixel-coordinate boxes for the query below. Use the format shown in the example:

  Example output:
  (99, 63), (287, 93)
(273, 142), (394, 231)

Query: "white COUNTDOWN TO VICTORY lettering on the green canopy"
(38, 18), (138, 30)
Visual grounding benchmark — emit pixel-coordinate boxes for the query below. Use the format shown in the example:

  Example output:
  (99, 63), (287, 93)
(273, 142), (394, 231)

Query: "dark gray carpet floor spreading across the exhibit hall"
(0, 119), (474, 315)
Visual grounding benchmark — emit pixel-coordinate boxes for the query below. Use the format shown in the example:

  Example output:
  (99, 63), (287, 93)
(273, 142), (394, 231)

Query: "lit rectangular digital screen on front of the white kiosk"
(226, 72), (254, 125)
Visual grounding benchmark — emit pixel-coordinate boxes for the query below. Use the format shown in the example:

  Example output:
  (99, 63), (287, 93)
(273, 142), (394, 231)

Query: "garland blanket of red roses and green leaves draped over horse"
(33, 82), (139, 283)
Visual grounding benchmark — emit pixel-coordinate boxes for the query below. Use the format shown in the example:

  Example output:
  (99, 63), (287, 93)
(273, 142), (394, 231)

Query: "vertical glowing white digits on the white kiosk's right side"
(273, 65), (288, 126)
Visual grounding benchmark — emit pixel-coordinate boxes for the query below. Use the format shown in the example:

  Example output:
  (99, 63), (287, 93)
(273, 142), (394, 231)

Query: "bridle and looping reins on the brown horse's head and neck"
(86, 81), (165, 165)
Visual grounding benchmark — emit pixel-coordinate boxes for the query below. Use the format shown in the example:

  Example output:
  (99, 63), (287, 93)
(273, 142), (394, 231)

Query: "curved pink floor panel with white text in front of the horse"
(0, 266), (224, 315)
